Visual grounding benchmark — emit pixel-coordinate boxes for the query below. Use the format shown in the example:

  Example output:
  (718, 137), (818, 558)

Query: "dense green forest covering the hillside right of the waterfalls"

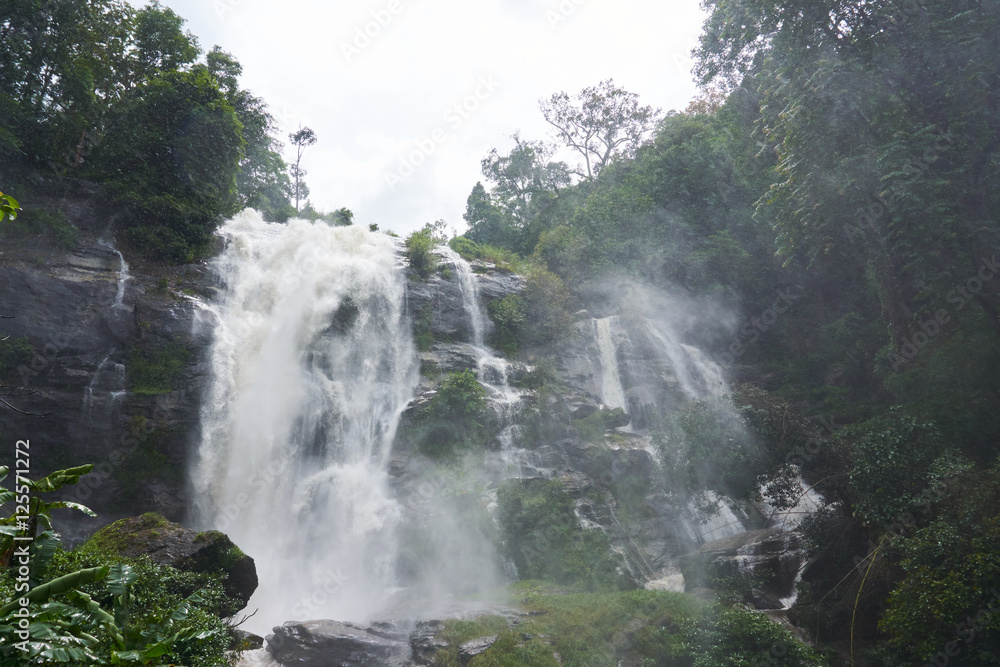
(456, 0), (1000, 665)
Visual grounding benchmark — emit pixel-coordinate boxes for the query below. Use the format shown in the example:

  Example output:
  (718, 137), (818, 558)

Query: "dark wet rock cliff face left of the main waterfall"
(0, 184), (214, 543)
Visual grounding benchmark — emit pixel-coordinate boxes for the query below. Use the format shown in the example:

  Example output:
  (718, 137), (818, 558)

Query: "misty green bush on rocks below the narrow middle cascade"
(497, 479), (629, 591)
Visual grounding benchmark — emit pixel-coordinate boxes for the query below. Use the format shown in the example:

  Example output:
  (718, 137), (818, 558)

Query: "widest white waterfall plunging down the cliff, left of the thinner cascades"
(192, 211), (418, 632)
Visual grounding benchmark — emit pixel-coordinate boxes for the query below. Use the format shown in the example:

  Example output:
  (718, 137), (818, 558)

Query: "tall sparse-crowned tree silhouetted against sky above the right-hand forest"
(539, 79), (660, 181)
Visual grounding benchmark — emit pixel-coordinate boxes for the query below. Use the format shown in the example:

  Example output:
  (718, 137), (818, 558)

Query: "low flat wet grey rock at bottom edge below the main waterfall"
(266, 621), (410, 667)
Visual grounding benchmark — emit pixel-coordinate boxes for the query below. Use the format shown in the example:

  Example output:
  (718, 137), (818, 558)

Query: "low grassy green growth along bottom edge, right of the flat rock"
(435, 581), (824, 667)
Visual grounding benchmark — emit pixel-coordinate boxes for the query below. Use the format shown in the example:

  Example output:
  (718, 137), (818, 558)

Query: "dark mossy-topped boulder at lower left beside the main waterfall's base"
(87, 512), (257, 606)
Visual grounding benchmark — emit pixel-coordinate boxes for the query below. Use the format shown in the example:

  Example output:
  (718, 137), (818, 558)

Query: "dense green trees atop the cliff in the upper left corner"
(0, 0), (340, 263)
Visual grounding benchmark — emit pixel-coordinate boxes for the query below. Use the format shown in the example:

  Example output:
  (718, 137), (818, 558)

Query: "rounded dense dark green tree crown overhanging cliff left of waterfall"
(94, 66), (245, 263)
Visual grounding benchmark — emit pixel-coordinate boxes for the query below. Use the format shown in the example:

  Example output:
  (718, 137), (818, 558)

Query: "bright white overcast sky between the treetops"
(145, 0), (704, 233)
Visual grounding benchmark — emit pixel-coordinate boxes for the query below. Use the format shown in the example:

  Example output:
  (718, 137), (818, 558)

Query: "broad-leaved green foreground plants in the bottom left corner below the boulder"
(0, 465), (242, 667)
